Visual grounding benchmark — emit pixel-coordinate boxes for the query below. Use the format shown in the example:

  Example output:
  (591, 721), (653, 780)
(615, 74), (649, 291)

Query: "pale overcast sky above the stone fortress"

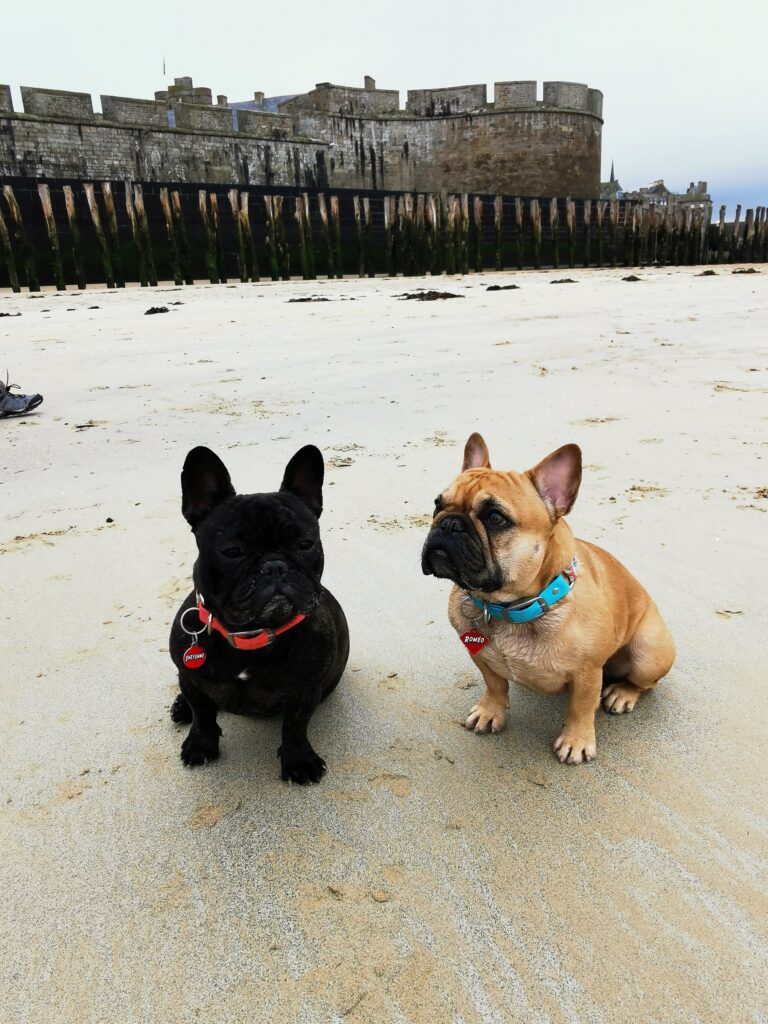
(0, 0), (768, 207)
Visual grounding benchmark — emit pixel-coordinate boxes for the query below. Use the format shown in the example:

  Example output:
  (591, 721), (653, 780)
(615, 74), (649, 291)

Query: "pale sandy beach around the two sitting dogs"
(0, 266), (768, 1024)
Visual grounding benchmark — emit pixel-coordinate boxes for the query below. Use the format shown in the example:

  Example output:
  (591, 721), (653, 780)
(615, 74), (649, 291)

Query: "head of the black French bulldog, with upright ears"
(181, 445), (324, 630)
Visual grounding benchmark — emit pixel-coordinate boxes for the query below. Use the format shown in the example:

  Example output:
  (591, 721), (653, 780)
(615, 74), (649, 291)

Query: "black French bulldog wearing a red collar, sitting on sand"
(169, 444), (349, 783)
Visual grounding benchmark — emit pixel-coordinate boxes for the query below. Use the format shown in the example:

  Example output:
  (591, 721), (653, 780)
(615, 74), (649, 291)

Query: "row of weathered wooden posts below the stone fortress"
(0, 178), (768, 291)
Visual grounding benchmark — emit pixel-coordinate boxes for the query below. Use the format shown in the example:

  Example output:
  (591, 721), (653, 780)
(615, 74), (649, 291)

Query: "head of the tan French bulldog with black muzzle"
(422, 434), (581, 600)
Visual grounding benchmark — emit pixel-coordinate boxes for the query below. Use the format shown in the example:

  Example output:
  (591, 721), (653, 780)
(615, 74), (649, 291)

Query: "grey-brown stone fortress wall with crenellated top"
(0, 75), (603, 197)
